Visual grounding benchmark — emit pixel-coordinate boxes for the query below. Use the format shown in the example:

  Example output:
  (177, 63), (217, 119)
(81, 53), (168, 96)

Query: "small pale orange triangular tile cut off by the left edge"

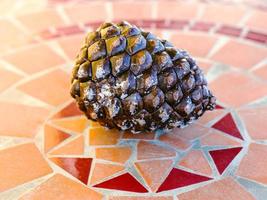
(0, 68), (22, 92)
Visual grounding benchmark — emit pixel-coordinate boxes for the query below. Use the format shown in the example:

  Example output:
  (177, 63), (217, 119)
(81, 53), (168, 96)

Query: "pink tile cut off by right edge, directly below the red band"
(212, 40), (267, 69)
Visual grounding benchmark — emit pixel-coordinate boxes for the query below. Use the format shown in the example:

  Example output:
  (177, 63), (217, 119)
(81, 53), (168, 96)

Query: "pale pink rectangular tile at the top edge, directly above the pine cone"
(112, 1), (153, 20)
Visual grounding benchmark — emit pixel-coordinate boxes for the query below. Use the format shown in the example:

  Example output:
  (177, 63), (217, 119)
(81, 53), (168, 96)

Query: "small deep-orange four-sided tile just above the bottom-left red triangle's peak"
(95, 147), (132, 163)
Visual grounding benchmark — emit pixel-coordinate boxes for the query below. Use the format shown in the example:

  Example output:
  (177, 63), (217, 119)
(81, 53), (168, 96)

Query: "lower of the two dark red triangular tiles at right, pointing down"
(209, 147), (242, 174)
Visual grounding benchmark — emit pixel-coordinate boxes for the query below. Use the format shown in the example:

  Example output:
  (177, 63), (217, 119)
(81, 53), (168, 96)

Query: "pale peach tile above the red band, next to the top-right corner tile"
(200, 4), (246, 25)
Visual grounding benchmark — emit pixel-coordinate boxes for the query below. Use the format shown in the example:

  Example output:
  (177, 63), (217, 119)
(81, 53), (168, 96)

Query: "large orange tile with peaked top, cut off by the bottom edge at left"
(21, 174), (102, 200)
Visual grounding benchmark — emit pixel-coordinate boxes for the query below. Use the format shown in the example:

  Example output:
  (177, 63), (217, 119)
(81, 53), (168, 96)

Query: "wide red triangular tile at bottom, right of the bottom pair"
(157, 168), (211, 192)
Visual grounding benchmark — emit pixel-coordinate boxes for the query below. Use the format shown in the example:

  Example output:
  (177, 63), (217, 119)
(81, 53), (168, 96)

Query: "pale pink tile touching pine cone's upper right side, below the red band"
(170, 33), (217, 57)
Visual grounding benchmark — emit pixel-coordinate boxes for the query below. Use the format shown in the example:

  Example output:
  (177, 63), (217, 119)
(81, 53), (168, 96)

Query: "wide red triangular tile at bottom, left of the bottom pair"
(94, 173), (148, 193)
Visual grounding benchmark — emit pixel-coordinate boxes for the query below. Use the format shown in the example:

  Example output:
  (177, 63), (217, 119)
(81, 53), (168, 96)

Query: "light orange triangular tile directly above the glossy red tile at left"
(49, 135), (84, 155)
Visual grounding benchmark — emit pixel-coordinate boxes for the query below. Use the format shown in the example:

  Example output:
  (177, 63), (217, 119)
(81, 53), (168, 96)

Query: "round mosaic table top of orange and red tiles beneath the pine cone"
(0, 0), (267, 200)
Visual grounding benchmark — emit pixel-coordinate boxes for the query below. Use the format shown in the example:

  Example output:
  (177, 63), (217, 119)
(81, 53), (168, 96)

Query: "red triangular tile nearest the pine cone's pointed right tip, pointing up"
(212, 113), (243, 140)
